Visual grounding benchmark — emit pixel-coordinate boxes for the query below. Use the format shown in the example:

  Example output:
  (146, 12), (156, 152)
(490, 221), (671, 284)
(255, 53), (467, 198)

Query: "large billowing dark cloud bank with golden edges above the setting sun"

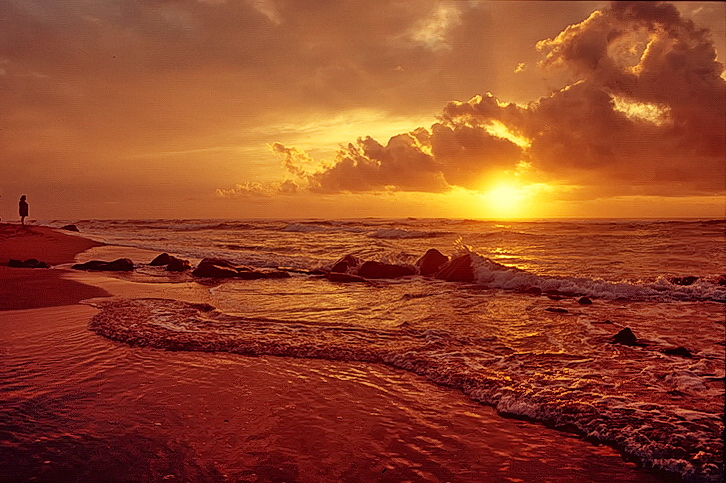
(218, 2), (726, 199)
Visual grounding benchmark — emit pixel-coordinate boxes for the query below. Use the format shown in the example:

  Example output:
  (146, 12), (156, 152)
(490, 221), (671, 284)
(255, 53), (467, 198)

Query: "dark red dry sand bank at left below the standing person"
(0, 224), (109, 310)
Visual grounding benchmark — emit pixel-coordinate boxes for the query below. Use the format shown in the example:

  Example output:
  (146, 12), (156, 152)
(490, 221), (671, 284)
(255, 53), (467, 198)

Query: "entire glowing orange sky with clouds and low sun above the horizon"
(0, 0), (726, 221)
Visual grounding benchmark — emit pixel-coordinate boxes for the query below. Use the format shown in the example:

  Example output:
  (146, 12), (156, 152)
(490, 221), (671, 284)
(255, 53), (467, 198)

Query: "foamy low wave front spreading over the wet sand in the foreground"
(90, 299), (723, 482)
